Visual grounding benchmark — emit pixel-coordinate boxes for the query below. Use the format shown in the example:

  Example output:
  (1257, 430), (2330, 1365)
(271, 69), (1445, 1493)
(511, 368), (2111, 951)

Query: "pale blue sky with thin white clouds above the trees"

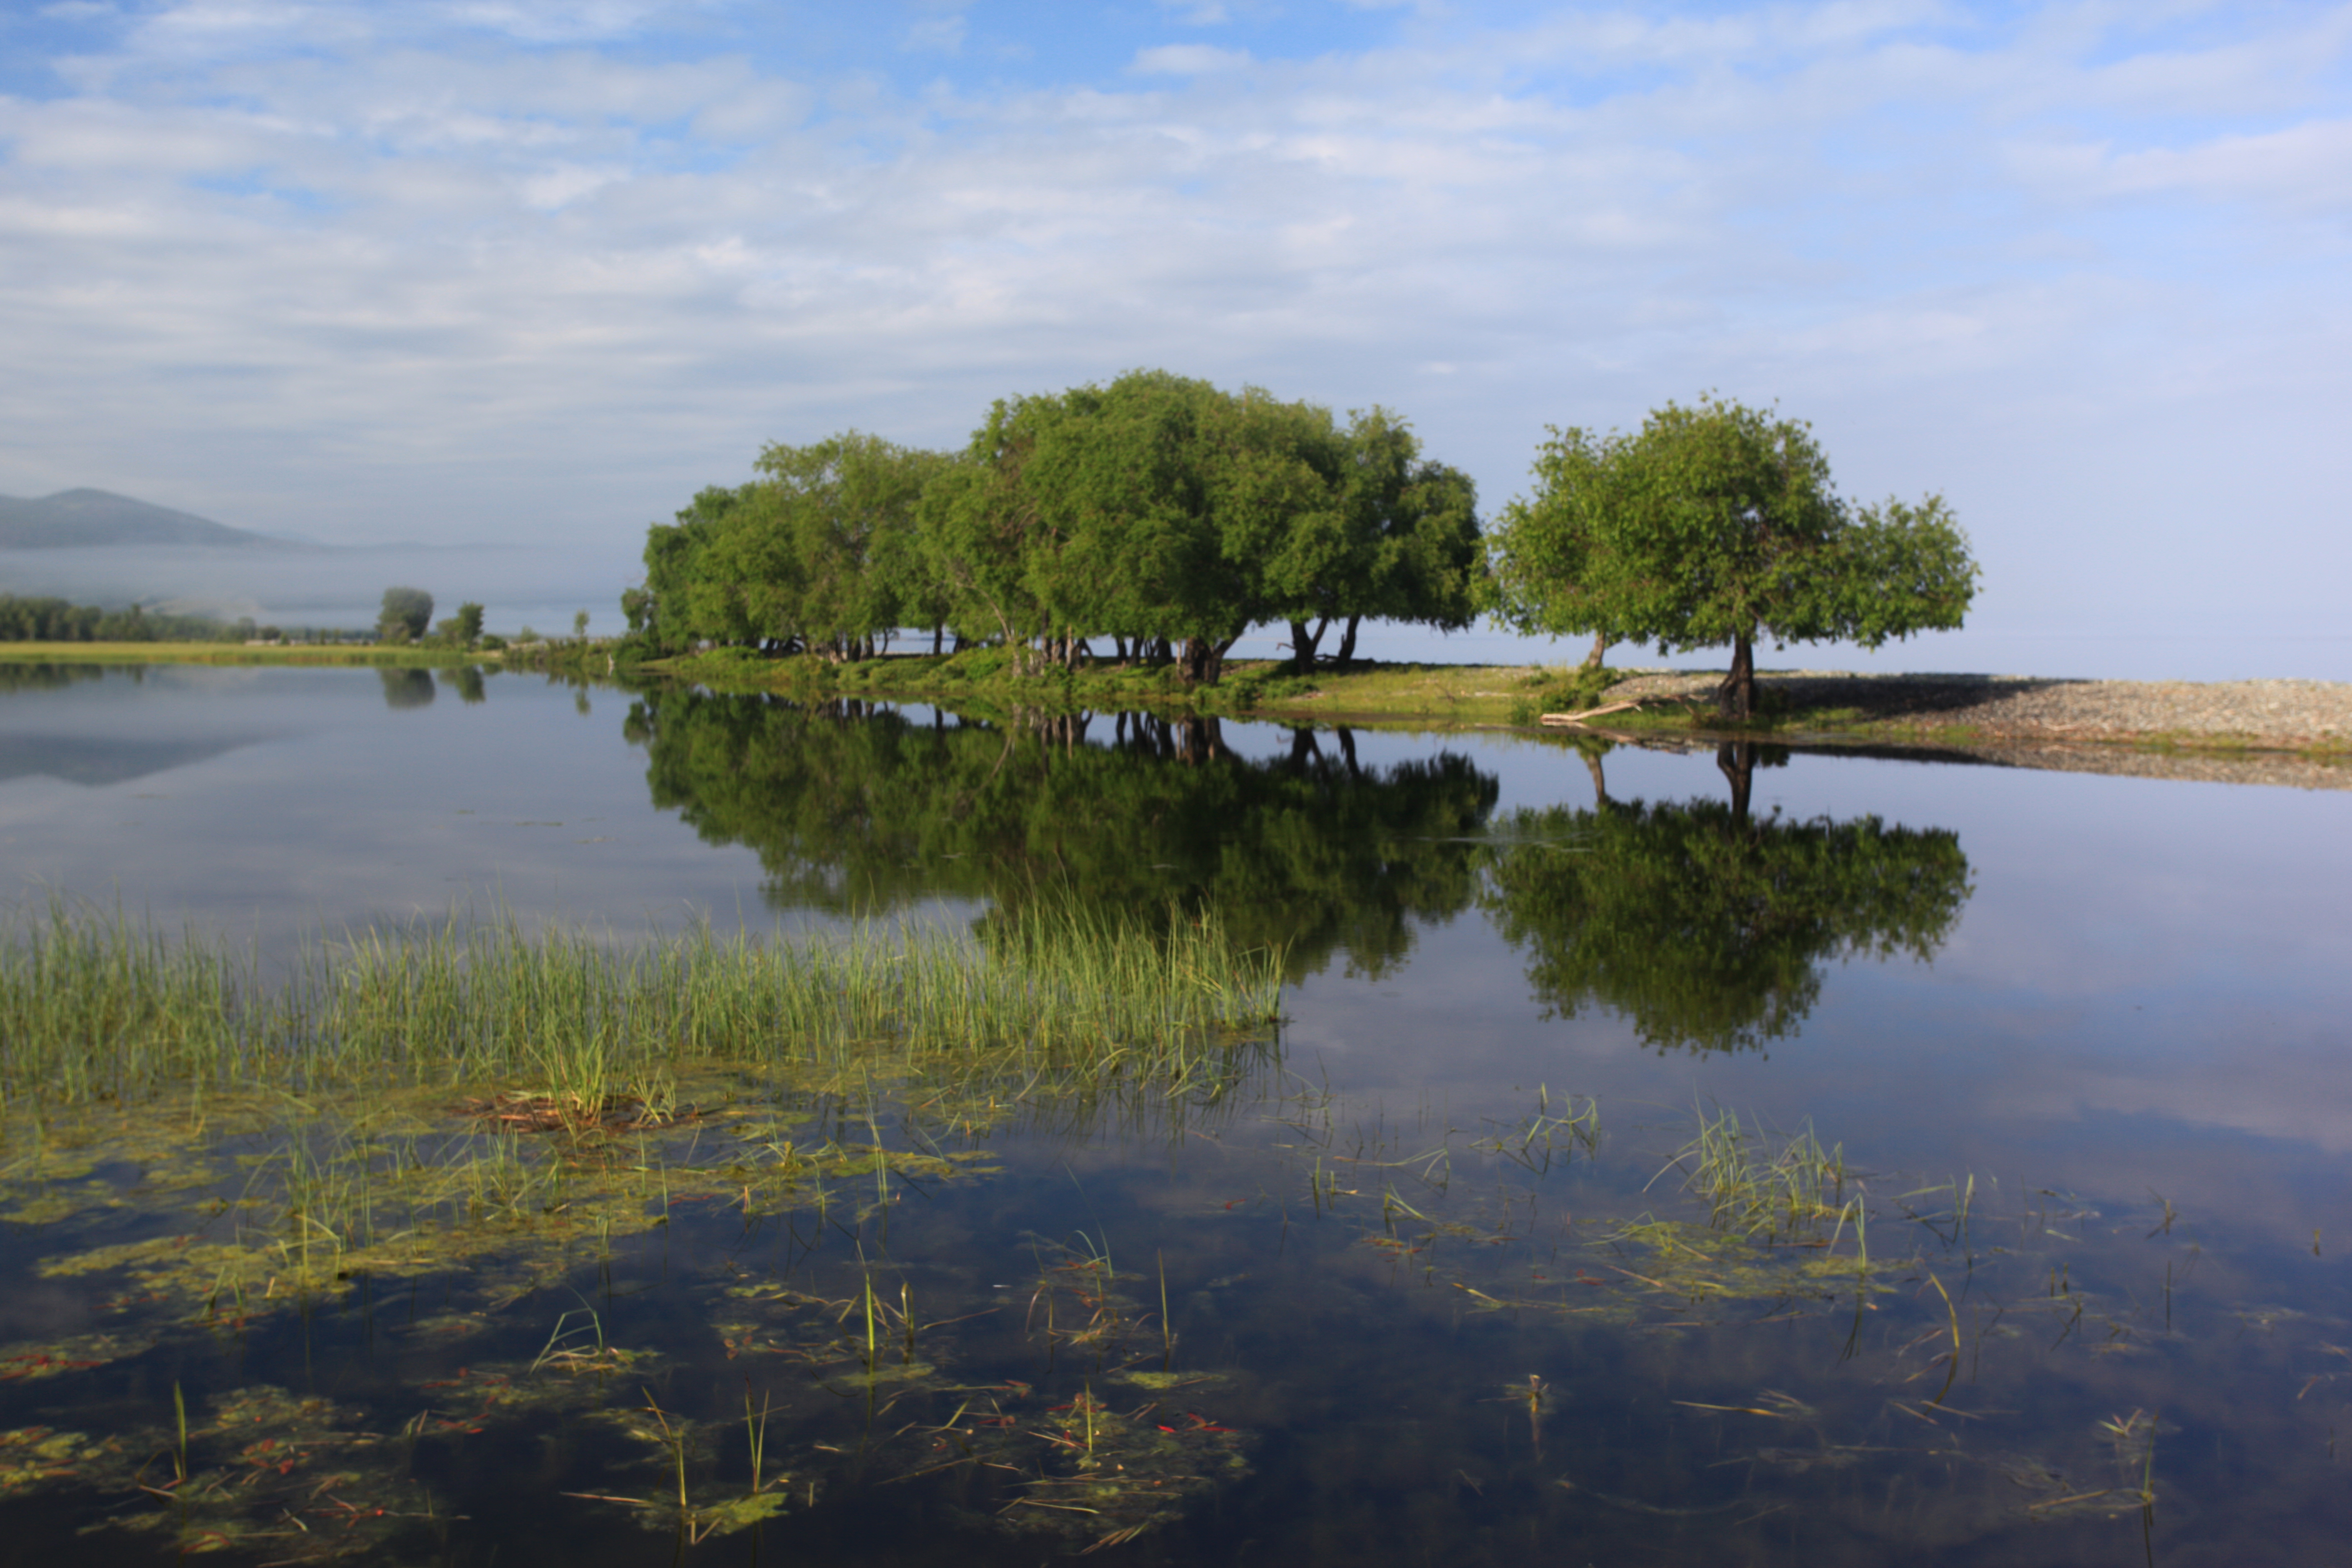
(0, 0), (2352, 677)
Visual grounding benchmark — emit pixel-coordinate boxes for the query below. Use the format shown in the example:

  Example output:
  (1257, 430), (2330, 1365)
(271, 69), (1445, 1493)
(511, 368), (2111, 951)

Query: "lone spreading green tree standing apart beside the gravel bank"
(1493, 395), (1978, 717)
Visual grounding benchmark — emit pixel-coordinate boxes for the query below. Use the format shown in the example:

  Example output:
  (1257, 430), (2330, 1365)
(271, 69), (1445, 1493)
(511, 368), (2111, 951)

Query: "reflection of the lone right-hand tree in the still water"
(1479, 743), (1969, 1051)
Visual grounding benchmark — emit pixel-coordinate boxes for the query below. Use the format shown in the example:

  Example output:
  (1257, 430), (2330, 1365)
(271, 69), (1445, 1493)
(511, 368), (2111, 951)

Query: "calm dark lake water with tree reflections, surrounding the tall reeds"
(0, 670), (2352, 1563)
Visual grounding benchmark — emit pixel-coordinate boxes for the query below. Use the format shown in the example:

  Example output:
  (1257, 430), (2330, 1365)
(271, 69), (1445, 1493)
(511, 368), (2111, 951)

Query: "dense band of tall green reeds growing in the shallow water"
(0, 905), (1282, 1103)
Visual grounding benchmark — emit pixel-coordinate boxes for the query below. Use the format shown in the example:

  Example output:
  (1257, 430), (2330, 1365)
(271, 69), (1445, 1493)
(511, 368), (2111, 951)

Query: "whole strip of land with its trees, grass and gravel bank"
(0, 369), (2352, 785)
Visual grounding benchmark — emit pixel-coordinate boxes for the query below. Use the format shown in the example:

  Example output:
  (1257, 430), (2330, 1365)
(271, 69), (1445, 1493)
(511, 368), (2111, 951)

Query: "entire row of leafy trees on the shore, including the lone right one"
(621, 371), (1975, 714)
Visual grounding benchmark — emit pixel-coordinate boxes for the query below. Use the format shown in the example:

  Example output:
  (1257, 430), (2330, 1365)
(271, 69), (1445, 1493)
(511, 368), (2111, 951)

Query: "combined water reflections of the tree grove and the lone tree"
(628, 689), (1969, 1051)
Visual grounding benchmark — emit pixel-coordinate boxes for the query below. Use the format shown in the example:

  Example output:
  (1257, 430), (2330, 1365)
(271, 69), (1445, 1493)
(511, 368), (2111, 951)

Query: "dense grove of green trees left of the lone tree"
(621, 371), (1484, 682)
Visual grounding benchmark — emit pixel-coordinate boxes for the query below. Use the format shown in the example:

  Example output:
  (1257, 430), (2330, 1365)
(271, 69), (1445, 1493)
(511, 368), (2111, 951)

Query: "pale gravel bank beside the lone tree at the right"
(1595, 670), (2352, 790)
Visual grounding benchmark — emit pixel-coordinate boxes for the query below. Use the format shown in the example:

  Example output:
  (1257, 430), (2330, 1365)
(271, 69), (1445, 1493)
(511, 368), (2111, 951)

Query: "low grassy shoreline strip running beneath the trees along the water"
(0, 642), (2352, 764)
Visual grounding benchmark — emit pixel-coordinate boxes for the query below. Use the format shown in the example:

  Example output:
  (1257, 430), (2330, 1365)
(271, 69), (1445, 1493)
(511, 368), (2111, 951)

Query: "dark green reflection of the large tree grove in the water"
(628, 691), (1498, 978)
